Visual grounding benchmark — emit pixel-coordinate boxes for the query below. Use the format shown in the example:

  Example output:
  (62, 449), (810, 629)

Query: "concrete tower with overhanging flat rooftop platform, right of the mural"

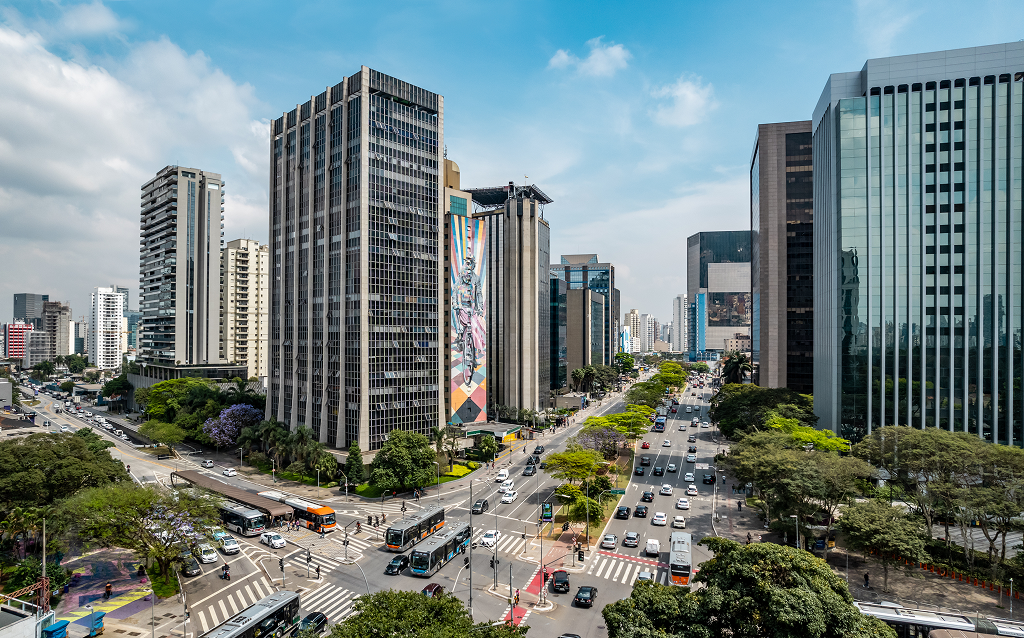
(466, 178), (552, 419)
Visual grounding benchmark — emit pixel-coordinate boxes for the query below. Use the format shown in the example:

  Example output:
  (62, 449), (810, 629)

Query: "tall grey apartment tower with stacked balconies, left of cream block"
(138, 166), (224, 369)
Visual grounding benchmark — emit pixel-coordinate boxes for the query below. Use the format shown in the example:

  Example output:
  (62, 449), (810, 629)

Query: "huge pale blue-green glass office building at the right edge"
(812, 42), (1024, 445)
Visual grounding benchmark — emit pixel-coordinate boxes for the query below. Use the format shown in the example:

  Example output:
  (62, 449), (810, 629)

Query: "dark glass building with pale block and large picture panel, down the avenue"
(686, 230), (752, 358)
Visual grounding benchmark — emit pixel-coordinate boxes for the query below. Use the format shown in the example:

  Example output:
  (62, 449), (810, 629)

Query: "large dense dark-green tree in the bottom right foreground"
(602, 537), (896, 638)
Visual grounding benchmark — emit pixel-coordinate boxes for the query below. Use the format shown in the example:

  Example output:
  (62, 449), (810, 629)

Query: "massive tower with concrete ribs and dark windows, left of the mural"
(267, 67), (449, 451)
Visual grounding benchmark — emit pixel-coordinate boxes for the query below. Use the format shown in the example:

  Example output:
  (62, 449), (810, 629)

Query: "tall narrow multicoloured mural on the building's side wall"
(449, 215), (487, 424)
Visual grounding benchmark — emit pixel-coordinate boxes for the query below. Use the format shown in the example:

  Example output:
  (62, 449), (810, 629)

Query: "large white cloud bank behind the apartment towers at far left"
(0, 24), (268, 318)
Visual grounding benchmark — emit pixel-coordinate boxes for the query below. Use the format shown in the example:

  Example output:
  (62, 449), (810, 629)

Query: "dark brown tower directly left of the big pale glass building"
(751, 121), (814, 394)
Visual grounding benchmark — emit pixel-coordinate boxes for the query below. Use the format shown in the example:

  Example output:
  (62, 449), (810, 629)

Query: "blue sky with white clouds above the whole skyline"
(0, 0), (1024, 322)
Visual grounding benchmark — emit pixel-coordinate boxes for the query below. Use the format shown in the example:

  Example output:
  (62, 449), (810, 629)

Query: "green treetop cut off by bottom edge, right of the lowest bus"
(329, 590), (528, 638)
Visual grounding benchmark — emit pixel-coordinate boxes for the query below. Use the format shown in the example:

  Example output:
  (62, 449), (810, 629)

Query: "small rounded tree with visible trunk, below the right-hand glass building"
(839, 501), (928, 592)
